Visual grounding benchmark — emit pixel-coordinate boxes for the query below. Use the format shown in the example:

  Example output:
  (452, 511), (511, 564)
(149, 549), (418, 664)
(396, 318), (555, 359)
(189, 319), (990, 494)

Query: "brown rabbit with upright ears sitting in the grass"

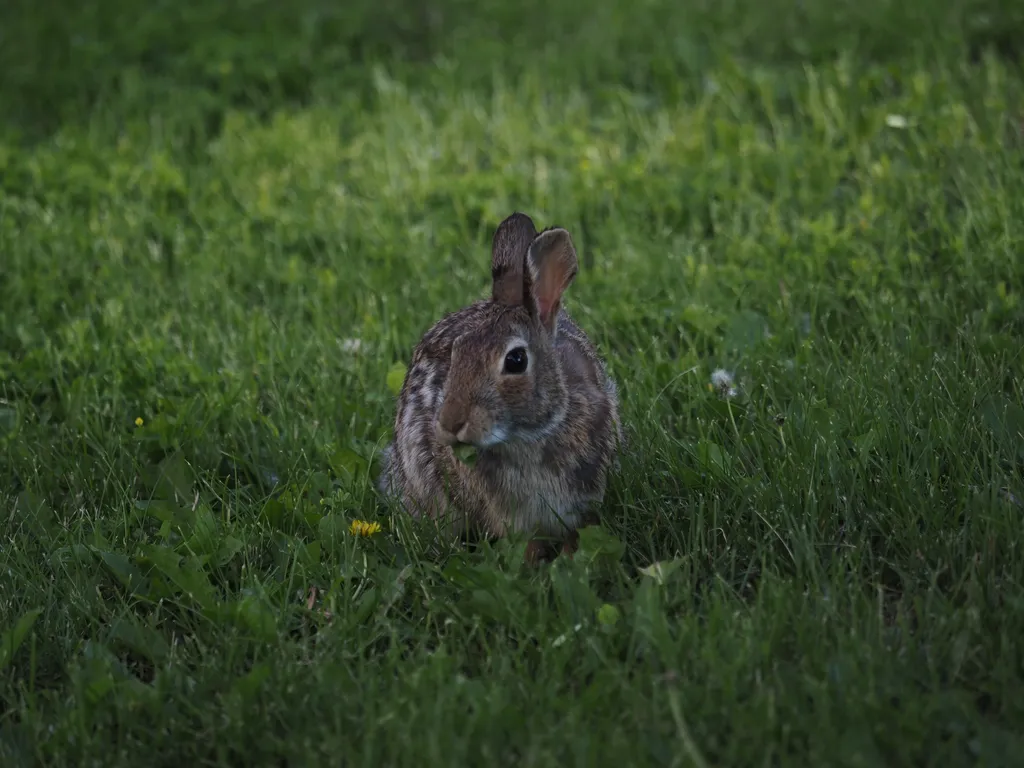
(378, 212), (623, 563)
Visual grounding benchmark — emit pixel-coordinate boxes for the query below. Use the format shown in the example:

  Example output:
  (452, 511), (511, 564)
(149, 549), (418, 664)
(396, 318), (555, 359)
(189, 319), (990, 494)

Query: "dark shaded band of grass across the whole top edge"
(6, 0), (1024, 145)
